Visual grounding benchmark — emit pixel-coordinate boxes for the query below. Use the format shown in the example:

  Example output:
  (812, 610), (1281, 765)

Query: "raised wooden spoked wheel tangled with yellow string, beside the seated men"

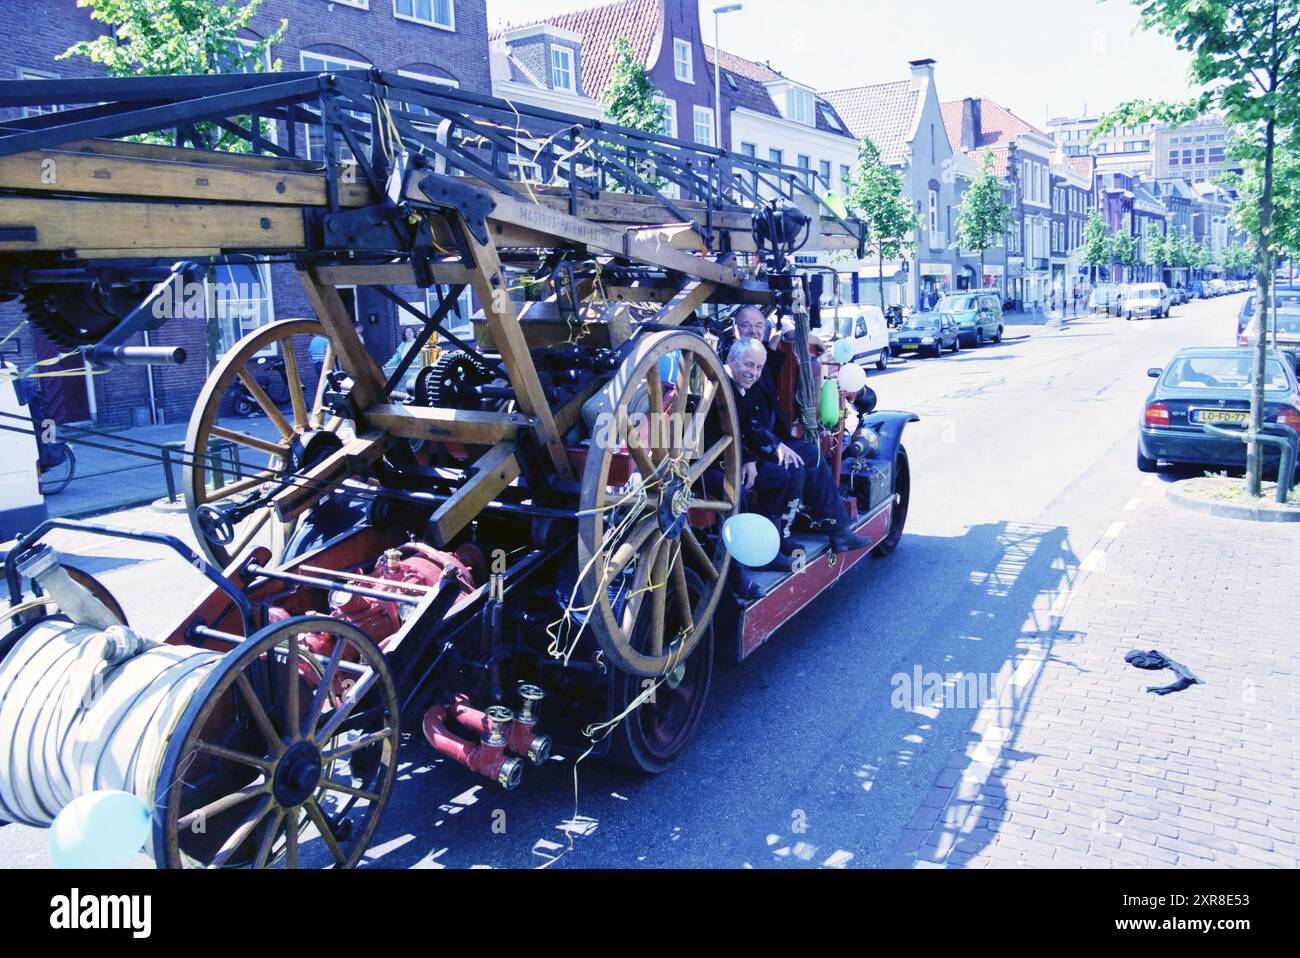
(579, 330), (741, 676)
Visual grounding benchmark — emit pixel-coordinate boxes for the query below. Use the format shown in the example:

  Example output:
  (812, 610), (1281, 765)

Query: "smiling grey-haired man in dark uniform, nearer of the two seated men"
(727, 338), (870, 555)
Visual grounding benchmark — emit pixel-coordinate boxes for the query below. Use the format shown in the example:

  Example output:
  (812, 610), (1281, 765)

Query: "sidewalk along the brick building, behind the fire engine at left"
(46, 416), (276, 519)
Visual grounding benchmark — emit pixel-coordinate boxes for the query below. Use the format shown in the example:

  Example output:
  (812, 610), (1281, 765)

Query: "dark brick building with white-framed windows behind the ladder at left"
(0, 0), (491, 426)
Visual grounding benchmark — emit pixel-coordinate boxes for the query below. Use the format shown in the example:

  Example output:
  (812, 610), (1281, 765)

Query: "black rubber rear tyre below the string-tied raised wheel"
(608, 569), (714, 775)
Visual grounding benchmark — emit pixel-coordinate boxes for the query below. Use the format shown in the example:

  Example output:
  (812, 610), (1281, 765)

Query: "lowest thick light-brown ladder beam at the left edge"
(0, 196), (307, 255)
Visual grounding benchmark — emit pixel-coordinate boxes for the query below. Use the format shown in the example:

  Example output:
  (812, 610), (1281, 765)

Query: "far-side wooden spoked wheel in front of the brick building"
(185, 320), (341, 568)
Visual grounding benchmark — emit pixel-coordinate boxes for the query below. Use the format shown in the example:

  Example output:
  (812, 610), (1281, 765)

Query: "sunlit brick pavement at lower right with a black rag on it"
(888, 482), (1300, 868)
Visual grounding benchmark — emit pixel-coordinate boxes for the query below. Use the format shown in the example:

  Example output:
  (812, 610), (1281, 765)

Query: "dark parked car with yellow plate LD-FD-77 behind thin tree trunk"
(1138, 346), (1300, 472)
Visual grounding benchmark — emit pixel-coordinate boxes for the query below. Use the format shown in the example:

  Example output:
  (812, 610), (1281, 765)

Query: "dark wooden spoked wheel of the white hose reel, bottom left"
(153, 615), (398, 868)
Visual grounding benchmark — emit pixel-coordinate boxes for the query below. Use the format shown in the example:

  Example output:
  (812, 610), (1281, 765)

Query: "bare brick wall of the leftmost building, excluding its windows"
(0, 0), (491, 426)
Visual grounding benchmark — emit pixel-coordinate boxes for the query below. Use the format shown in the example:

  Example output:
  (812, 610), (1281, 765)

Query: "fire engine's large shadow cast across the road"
(351, 523), (1078, 867)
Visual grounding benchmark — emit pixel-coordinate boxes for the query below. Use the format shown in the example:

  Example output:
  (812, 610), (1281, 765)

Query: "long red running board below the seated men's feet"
(736, 497), (894, 660)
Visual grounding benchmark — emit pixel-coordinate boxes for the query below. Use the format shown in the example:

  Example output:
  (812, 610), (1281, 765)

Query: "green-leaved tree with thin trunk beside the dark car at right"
(1097, 0), (1300, 498)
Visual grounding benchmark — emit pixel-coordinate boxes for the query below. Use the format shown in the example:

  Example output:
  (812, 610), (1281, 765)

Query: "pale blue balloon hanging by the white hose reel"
(49, 789), (151, 868)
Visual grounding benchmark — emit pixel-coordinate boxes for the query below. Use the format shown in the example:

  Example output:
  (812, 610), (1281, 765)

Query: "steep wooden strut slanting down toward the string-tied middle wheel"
(456, 213), (573, 480)
